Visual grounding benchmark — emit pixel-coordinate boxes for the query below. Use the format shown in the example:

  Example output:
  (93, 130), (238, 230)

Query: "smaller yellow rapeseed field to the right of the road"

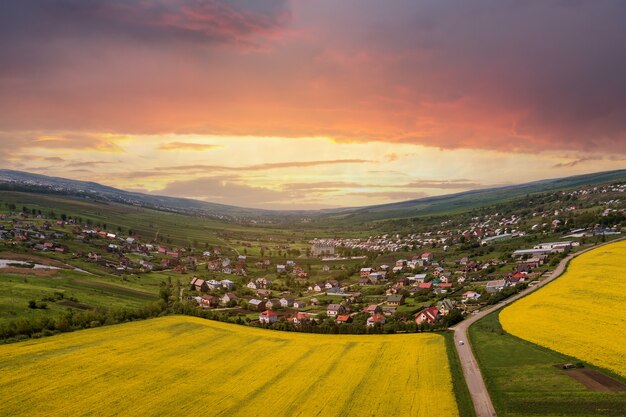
(500, 237), (626, 376)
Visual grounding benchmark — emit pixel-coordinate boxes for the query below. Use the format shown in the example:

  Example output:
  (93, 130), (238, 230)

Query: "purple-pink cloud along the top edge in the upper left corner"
(0, 0), (290, 48)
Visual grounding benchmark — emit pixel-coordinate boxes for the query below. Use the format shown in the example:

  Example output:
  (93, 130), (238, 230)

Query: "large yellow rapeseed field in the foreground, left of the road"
(0, 317), (458, 417)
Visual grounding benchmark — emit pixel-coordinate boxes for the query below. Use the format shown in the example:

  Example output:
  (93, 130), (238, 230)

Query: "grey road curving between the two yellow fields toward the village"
(450, 237), (626, 417)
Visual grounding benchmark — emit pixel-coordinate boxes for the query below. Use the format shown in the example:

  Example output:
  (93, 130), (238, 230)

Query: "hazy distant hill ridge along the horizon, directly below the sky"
(0, 169), (626, 222)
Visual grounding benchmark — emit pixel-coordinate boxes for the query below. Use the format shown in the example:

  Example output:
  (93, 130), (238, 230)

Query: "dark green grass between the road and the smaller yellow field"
(469, 313), (626, 417)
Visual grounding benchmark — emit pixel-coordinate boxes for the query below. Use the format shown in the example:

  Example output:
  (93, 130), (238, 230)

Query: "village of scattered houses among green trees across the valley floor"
(0, 179), (624, 333)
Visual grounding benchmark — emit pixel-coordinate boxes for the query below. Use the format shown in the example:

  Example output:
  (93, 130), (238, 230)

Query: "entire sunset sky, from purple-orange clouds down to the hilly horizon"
(0, 0), (626, 209)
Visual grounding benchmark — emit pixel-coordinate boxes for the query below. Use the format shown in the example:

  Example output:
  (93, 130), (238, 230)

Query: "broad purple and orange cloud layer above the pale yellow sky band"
(0, 0), (626, 155)
